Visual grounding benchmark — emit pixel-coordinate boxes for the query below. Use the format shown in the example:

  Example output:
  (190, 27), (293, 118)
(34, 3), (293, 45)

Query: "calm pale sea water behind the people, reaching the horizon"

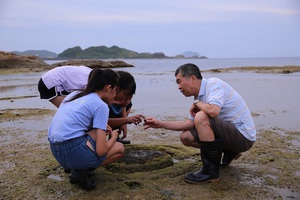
(0, 58), (300, 130)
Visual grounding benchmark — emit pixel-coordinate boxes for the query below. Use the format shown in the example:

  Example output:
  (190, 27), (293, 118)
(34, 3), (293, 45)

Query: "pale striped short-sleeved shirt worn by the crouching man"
(189, 78), (256, 141)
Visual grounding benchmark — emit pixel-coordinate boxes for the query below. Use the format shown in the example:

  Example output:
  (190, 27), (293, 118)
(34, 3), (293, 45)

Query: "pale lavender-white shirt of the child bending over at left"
(42, 66), (92, 92)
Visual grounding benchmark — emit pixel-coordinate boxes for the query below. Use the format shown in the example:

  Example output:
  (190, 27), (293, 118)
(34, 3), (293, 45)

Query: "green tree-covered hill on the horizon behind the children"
(58, 46), (166, 59)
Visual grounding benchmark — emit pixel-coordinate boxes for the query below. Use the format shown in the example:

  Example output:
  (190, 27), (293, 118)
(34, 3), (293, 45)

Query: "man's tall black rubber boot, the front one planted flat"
(184, 141), (223, 184)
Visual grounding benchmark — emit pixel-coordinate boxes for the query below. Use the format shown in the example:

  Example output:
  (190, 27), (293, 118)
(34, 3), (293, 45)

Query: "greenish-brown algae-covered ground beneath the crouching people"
(0, 109), (300, 199)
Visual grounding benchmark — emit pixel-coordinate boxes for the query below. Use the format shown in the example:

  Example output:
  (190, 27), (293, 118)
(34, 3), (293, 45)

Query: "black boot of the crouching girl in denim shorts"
(69, 170), (96, 190)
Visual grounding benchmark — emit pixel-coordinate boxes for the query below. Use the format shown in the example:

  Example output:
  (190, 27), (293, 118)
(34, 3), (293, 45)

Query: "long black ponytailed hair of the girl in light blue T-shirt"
(68, 68), (119, 101)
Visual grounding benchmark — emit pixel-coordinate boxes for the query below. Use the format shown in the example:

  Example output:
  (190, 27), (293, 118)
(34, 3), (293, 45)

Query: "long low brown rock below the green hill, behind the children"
(51, 59), (134, 68)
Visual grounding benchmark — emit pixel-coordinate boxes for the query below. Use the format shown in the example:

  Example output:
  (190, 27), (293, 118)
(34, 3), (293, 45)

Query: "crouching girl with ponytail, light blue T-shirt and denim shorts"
(48, 68), (125, 190)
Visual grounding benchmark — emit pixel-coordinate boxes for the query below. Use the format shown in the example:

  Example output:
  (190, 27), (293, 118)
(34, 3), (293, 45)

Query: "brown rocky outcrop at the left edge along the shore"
(0, 51), (49, 69)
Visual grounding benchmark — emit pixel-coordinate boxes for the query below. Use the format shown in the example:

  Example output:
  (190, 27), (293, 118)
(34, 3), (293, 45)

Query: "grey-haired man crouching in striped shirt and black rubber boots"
(144, 63), (256, 184)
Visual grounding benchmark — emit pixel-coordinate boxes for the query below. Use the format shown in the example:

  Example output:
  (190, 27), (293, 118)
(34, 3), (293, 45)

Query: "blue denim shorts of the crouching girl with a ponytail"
(50, 134), (106, 170)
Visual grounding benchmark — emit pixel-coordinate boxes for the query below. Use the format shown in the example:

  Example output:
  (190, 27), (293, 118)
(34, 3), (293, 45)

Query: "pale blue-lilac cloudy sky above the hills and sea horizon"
(0, 0), (300, 58)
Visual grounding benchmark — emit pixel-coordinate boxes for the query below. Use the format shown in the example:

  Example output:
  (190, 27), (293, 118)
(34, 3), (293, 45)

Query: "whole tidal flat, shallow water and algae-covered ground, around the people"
(0, 67), (300, 199)
